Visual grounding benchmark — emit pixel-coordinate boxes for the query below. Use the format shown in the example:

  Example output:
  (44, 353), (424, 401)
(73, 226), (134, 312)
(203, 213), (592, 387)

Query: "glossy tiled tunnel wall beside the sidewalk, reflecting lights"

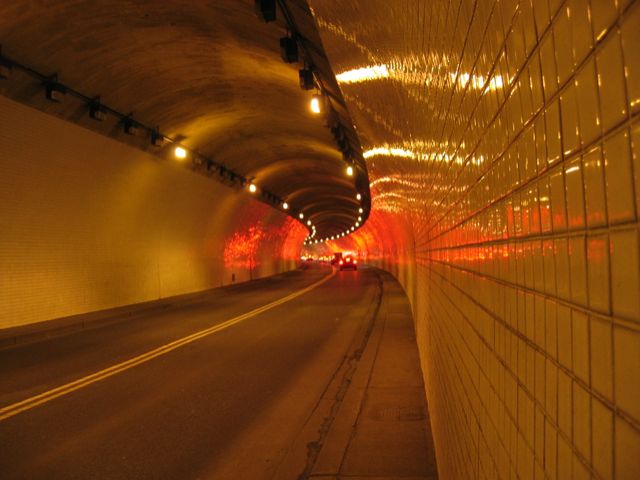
(310, 0), (640, 479)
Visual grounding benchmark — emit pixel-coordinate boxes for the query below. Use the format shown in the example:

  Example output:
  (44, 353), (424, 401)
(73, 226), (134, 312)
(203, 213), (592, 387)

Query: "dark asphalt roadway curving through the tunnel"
(0, 267), (380, 480)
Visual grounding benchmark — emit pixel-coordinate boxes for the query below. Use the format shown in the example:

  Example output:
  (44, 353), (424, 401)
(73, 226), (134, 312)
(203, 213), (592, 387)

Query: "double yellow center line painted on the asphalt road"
(0, 269), (336, 421)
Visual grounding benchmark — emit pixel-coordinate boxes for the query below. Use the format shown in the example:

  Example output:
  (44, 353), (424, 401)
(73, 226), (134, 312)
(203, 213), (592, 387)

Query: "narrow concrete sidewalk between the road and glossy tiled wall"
(276, 271), (437, 480)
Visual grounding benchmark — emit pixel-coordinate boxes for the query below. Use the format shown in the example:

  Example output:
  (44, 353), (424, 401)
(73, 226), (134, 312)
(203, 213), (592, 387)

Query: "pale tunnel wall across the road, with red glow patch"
(0, 97), (307, 329)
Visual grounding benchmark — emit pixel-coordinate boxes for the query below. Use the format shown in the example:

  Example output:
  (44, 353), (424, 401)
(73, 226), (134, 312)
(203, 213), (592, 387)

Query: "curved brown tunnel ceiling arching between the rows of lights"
(0, 0), (370, 237)
